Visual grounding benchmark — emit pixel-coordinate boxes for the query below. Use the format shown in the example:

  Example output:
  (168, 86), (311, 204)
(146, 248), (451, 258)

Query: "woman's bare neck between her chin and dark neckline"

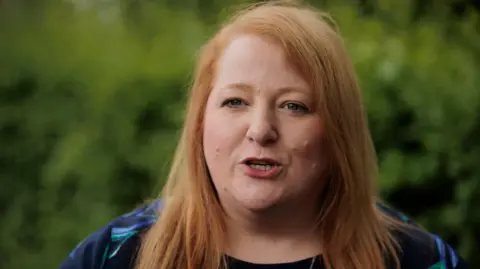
(225, 199), (321, 263)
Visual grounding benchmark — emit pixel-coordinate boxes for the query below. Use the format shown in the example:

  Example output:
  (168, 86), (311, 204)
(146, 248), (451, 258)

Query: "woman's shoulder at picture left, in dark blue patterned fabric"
(59, 201), (161, 269)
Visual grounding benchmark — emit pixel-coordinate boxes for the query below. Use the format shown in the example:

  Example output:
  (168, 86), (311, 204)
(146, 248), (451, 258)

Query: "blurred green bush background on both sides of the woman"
(0, 0), (480, 269)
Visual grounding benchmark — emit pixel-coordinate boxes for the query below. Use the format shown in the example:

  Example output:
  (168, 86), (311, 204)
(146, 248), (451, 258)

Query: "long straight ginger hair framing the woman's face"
(136, 1), (400, 269)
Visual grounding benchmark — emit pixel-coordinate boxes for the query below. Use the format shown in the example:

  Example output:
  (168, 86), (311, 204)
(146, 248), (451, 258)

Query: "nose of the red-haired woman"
(246, 109), (278, 145)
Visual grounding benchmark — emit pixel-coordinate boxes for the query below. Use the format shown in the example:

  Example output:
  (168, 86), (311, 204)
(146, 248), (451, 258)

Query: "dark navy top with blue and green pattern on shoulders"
(59, 201), (467, 269)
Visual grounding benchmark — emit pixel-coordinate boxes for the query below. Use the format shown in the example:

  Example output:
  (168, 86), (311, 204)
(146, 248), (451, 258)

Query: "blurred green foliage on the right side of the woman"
(338, 4), (480, 262)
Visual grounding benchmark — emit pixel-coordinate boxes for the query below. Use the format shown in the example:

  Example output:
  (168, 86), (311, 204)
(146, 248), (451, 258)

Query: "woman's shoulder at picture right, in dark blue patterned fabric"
(379, 205), (467, 269)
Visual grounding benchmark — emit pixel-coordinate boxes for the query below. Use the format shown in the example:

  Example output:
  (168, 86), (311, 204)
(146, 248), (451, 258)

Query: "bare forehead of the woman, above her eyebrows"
(215, 35), (309, 89)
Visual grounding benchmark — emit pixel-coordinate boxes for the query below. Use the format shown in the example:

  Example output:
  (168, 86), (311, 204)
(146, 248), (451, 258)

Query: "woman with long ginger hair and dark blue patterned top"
(60, 2), (466, 269)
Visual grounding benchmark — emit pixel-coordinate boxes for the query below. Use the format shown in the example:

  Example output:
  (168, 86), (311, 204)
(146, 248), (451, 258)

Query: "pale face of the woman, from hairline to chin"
(203, 35), (325, 211)
